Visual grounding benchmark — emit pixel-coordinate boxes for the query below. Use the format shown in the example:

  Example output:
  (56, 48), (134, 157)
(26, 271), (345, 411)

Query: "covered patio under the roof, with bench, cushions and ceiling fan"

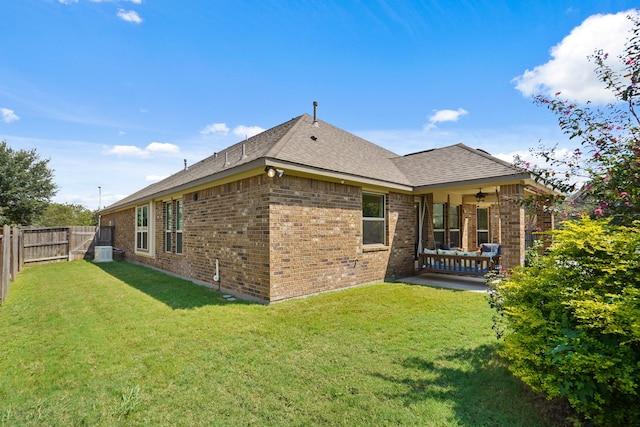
(416, 180), (554, 276)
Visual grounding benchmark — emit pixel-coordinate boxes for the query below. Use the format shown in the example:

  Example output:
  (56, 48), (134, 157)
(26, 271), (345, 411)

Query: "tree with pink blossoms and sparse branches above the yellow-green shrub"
(516, 14), (640, 225)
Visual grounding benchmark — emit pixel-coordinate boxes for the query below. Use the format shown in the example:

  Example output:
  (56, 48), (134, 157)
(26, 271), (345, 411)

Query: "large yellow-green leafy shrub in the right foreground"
(490, 217), (640, 426)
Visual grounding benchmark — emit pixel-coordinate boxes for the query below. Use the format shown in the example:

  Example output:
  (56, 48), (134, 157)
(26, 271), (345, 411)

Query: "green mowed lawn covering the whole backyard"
(0, 261), (568, 426)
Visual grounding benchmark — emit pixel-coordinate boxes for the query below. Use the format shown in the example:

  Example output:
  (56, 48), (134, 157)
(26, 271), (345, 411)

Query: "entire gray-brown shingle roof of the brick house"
(106, 114), (521, 211)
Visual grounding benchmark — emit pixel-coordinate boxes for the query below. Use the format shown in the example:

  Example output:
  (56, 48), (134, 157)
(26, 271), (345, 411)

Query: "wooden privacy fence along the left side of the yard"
(0, 225), (114, 304)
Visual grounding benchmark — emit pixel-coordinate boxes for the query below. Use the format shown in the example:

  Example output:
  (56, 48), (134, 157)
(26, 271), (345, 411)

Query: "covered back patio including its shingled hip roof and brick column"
(397, 144), (555, 269)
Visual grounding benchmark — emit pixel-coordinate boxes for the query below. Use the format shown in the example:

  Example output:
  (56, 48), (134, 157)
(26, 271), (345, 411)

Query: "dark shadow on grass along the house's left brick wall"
(95, 262), (250, 310)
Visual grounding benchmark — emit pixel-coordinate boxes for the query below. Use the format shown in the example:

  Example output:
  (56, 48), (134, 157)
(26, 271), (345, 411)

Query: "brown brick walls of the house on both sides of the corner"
(103, 175), (416, 302)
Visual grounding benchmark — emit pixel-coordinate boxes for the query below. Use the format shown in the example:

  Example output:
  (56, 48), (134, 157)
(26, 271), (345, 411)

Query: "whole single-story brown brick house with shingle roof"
(101, 114), (553, 303)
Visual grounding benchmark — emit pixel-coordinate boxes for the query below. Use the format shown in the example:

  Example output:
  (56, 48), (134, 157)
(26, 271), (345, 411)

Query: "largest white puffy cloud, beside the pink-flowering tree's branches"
(513, 10), (636, 103)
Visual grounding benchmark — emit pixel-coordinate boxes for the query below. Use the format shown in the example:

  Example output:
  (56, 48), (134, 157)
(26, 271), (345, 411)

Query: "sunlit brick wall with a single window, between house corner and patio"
(270, 179), (415, 301)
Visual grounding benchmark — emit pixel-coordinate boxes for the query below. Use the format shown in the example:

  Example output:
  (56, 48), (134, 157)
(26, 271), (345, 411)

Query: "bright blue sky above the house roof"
(0, 0), (637, 209)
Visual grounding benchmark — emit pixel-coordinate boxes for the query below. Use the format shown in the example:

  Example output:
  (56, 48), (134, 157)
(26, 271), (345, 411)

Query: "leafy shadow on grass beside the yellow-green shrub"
(374, 343), (575, 426)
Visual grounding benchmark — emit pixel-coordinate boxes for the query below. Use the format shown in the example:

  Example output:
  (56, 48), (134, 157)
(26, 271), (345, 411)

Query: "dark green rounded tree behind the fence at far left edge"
(0, 141), (57, 225)
